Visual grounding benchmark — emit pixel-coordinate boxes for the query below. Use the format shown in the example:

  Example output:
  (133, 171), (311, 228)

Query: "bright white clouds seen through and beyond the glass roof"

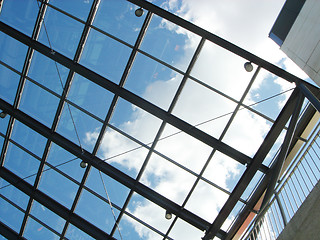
(88, 0), (310, 239)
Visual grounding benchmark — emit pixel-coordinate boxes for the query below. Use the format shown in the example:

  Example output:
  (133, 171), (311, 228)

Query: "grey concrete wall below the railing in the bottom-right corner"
(277, 182), (320, 240)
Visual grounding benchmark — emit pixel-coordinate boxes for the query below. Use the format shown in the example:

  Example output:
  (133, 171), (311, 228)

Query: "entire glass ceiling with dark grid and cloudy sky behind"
(0, 0), (320, 239)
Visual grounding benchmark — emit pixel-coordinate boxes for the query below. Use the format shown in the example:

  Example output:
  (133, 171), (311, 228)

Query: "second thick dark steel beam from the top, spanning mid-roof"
(0, 22), (252, 170)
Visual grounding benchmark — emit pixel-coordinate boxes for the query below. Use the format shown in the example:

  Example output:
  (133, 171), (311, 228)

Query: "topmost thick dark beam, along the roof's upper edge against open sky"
(128, 0), (303, 83)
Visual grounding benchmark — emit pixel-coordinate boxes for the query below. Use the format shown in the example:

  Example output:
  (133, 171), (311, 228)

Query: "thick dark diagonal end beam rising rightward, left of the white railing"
(203, 89), (298, 240)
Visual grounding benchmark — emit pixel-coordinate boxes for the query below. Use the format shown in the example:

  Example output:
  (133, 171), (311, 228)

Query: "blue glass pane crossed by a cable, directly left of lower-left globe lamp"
(45, 143), (85, 183)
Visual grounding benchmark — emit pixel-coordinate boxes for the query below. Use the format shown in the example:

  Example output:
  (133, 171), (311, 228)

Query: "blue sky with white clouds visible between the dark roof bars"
(0, 0), (312, 239)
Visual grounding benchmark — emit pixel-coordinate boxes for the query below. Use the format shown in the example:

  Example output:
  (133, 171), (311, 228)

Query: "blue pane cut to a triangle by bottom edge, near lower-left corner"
(23, 217), (60, 240)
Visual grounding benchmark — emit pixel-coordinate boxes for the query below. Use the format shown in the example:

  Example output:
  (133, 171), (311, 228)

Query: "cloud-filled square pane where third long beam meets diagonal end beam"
(185, 180), (229, 222)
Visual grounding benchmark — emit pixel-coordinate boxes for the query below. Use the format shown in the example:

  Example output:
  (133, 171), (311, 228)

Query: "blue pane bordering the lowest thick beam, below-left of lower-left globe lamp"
(39, 166), (80, 208)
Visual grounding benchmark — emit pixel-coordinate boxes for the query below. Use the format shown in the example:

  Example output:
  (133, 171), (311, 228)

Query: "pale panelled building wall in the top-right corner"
(280, 0), (320, 86)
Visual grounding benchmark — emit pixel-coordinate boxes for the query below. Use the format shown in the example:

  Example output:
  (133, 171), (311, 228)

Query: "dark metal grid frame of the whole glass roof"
(0, 0), (320, 239)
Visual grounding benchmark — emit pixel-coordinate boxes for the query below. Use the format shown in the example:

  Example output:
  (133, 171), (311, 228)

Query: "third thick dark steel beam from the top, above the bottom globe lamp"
(0, 99), (210, 231)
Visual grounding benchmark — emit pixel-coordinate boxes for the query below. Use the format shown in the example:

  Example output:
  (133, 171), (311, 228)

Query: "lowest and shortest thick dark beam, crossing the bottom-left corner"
(0, 167), (115, 240)
